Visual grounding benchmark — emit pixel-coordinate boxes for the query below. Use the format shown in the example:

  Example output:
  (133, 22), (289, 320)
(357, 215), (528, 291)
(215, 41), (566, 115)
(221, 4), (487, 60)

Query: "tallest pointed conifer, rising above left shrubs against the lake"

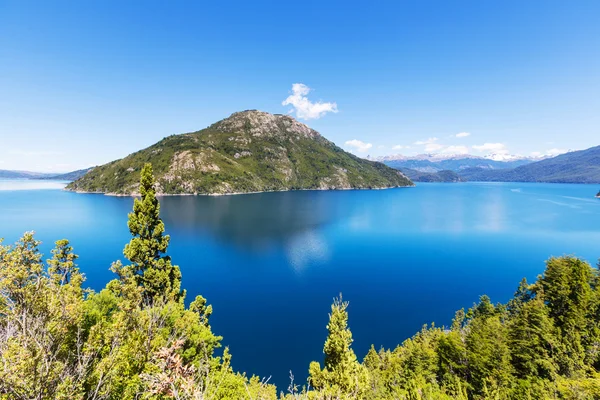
(123, 163), (183, 304)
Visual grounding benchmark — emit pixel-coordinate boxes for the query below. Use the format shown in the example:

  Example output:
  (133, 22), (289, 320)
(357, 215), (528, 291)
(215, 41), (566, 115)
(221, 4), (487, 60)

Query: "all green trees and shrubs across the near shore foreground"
(0, 165), (600, 400)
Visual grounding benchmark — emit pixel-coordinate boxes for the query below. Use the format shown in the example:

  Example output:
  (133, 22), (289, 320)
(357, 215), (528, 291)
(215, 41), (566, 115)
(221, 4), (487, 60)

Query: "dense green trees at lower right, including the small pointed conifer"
(287, 256), (600, 400)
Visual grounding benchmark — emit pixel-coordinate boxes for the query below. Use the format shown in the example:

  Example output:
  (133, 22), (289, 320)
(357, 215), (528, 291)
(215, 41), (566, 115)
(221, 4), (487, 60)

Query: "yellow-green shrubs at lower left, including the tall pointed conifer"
(0, 166), (276, 400)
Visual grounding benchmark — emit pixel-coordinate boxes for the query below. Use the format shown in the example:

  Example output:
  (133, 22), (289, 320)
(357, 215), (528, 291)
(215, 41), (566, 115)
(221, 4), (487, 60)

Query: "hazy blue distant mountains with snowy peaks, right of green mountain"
(382, 146), (600, 183)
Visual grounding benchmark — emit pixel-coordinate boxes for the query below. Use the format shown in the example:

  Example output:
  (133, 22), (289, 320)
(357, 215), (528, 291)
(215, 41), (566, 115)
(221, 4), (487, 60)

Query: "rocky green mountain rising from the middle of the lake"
(67, 110), (412, 194)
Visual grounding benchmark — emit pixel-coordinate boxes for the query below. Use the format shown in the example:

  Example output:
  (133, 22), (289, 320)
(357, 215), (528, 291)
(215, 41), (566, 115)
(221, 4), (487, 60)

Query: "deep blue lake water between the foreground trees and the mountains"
(0, 182), (600, 389)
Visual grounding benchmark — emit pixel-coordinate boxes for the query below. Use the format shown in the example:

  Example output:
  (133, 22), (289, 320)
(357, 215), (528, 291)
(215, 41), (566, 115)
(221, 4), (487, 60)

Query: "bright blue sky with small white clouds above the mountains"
(0, 0), (600, 171)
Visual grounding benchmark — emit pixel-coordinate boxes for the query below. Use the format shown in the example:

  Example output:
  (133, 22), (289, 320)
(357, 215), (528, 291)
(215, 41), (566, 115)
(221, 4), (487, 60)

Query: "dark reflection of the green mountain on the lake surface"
(161, 191), (350, 250)
